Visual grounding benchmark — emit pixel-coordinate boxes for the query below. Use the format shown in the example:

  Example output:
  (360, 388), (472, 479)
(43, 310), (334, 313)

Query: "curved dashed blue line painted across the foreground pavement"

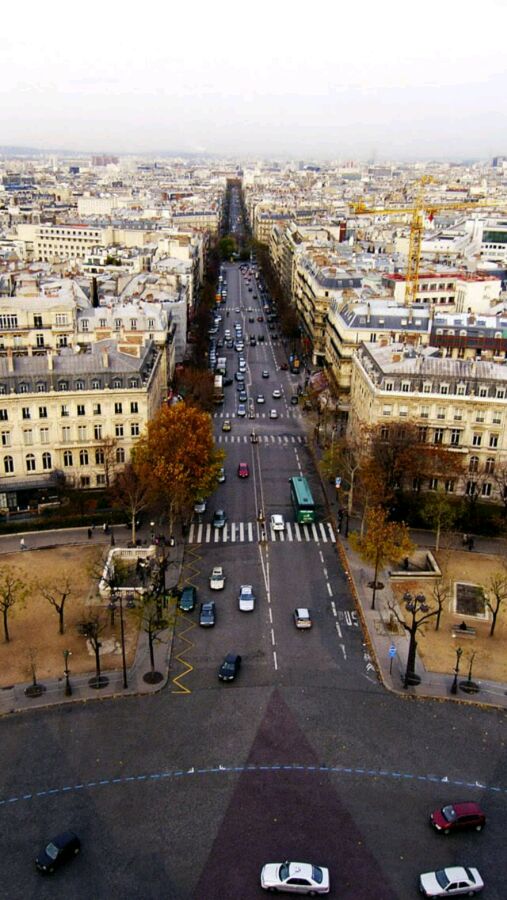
(0, 763), (507, 807)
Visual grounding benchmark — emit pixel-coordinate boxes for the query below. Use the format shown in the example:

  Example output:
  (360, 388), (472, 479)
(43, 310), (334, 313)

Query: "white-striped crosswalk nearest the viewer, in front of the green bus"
(188, 521), (336, 544)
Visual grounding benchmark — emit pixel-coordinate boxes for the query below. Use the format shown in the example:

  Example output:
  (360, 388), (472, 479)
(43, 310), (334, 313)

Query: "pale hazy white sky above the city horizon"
(0, 0), (507, 159)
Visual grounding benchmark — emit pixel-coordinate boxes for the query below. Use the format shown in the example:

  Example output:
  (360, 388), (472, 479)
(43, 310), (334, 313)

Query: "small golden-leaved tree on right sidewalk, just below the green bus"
(350, 506), (414, 609)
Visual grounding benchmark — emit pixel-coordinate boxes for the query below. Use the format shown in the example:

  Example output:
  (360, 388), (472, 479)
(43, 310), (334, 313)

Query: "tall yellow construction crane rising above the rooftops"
(351, 175), (507, 306)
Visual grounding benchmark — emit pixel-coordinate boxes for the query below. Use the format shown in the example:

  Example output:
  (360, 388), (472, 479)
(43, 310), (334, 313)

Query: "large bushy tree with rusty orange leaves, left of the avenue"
(134, 403), (224, 531)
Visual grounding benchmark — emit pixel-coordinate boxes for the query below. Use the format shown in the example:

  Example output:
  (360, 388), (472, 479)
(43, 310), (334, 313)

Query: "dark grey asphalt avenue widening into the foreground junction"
(0, 267), (507, 900)
